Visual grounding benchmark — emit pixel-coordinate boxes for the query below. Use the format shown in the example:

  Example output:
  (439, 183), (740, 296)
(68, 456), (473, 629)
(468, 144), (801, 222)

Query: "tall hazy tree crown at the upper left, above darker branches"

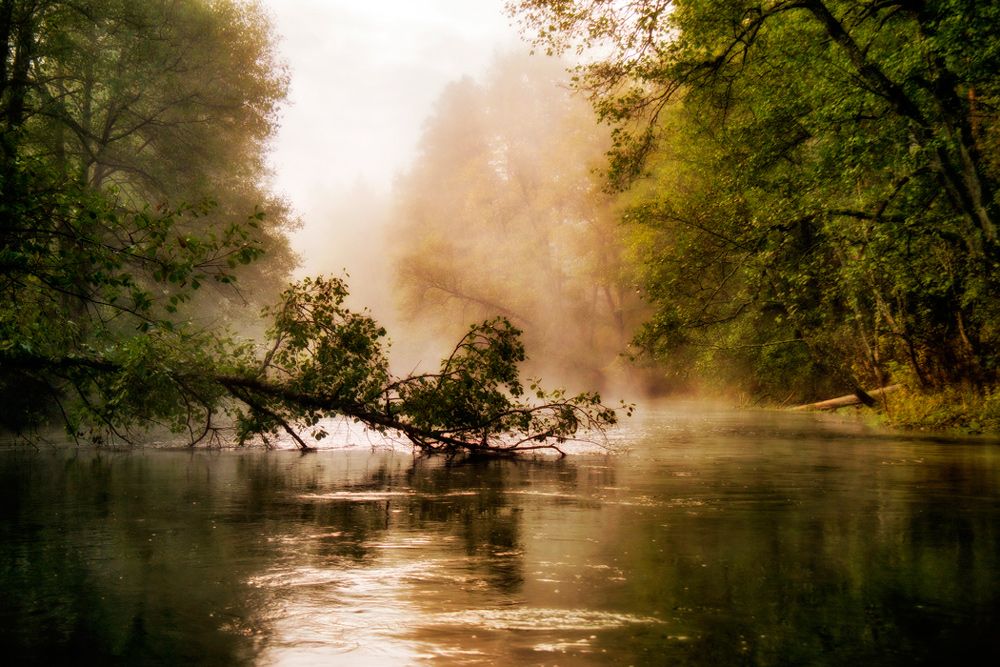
(0, 0), (294, 308)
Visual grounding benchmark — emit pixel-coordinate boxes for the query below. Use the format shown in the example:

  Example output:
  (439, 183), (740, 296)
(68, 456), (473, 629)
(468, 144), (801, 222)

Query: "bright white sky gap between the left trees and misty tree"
(264, 0), (528, 273)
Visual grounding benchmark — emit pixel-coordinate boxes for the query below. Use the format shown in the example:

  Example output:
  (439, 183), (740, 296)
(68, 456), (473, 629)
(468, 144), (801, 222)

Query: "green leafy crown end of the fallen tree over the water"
(217, 278), (617, 454)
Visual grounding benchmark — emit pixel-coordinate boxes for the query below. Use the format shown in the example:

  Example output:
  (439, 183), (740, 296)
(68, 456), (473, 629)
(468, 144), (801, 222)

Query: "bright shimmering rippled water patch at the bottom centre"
(249, 557), (664, 667)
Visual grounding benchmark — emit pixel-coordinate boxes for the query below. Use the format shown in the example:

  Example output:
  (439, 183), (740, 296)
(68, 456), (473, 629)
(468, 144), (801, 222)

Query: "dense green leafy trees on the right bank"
(508, 0), (1000, 400)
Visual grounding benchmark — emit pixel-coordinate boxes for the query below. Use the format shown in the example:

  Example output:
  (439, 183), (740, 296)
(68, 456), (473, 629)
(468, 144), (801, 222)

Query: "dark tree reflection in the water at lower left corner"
(0, 453), (262, 664)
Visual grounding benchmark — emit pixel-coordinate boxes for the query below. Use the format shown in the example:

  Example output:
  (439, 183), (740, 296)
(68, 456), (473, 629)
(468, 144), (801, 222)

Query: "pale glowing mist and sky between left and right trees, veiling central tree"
(262, 0), (656, 396)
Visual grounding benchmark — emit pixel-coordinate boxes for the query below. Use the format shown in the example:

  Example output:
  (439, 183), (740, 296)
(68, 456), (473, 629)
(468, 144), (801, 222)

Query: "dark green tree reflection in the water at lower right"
(607, 452), (1000, 665)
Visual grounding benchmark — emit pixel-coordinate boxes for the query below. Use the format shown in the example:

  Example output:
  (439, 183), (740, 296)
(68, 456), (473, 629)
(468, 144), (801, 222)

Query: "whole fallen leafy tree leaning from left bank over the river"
(2, 278), (631, 455)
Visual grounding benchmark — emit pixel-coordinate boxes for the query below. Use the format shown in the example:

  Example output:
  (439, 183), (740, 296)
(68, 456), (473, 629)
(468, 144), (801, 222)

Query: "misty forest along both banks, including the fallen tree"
(0, 0), (1000, 453)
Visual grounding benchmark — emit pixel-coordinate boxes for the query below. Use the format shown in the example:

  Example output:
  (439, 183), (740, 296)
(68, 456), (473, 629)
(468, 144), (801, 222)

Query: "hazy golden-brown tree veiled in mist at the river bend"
(393, 56), (638, 392)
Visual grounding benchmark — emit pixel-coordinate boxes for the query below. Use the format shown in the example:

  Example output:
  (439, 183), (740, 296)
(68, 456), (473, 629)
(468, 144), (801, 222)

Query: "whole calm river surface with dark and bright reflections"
(0, 408), (1000, 666)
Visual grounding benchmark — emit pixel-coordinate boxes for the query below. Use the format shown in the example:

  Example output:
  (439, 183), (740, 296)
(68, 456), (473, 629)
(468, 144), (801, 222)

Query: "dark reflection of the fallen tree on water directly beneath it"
(236, 458), (548, 593)
